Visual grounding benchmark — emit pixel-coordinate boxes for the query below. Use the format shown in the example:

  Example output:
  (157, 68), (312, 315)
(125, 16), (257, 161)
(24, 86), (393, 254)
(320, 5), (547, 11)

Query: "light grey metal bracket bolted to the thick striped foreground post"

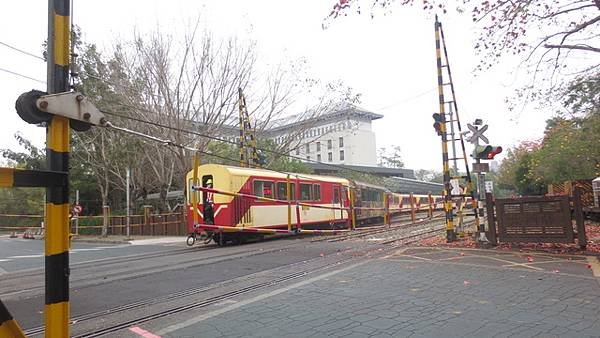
(36, 92), (108, 127)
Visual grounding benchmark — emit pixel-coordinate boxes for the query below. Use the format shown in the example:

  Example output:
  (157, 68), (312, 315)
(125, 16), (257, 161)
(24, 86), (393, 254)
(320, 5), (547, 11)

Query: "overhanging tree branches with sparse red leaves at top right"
(326, 0), (600, 105)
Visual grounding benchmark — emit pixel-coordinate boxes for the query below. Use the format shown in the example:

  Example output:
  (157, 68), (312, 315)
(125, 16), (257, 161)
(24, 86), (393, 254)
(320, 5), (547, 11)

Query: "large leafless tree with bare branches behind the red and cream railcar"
(73, 17), (355, 208)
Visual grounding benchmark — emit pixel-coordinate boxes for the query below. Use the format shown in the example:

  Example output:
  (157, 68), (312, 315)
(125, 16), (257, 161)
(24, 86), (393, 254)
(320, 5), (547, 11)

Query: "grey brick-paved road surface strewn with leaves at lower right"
(156, 249), (600, 337)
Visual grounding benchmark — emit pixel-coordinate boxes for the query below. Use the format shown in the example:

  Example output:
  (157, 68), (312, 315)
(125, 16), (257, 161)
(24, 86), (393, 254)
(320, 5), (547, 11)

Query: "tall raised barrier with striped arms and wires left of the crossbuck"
(433, 15), (479, 242)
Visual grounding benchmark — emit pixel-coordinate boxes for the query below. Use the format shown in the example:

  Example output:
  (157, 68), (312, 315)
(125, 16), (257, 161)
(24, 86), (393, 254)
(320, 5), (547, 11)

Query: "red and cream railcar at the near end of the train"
(186, 164), (350, 233)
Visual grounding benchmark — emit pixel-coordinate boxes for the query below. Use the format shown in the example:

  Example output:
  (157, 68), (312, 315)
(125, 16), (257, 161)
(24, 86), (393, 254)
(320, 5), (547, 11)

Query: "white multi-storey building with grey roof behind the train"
(265, 105), (383, 166)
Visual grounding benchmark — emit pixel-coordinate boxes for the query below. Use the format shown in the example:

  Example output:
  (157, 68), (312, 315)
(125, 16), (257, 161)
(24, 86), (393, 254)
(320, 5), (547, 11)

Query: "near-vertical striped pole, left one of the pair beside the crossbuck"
(435, 16), (456, 242)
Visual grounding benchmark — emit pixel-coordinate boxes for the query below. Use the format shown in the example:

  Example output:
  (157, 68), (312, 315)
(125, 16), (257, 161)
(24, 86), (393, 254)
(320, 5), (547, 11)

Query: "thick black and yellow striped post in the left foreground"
(44, 0), (70, 337)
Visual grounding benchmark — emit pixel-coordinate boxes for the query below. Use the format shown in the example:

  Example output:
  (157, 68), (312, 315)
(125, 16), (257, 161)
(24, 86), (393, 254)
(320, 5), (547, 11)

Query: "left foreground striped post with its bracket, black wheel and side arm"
(0, 0), (102, 337)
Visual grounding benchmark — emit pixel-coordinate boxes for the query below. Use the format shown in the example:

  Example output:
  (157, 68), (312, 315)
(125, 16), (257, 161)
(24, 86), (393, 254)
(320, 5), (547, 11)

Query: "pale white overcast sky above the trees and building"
(0, 0), (551, 171)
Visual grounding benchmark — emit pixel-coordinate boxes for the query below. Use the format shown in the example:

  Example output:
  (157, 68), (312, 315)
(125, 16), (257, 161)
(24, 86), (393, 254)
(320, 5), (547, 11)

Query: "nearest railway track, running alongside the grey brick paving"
(25, 218), (454, 337)
